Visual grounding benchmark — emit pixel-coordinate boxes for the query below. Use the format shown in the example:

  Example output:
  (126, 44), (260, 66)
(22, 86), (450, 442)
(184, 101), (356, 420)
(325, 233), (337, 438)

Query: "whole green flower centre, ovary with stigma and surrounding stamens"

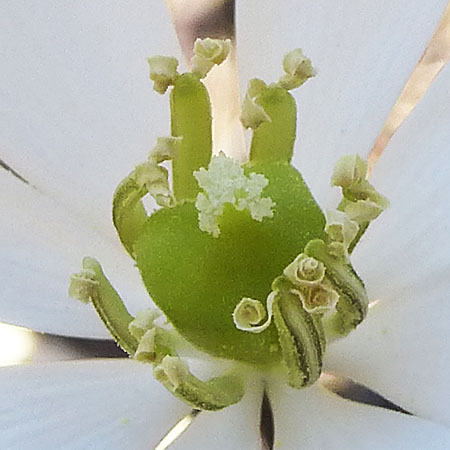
(70, 39), (387, 409)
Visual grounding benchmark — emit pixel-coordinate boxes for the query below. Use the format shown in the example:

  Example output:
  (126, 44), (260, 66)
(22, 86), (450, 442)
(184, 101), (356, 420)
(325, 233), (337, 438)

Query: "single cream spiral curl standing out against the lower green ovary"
(233, 292), (275, 333)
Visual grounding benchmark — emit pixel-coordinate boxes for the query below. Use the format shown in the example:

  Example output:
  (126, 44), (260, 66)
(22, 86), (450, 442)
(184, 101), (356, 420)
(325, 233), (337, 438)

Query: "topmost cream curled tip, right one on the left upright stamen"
(191, 38), (231, 78)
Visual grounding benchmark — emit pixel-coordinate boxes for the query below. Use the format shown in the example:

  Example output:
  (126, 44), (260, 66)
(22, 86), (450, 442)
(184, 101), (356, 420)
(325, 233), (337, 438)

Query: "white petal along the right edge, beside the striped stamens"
(327, 64), (450, 424)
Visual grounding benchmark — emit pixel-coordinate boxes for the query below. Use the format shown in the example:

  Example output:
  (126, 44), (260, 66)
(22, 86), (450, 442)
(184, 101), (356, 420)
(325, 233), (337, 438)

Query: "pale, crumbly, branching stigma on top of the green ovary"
(194, 154), (275, 237)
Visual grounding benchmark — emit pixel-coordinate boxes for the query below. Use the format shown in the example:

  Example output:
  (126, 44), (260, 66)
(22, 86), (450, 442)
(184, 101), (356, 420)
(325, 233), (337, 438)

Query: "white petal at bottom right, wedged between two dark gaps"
(269, 384), (450, 450)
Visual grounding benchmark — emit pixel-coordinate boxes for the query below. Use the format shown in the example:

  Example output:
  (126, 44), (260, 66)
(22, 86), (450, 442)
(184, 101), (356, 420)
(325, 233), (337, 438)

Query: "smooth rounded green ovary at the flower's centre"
(134, 162), (325, 365)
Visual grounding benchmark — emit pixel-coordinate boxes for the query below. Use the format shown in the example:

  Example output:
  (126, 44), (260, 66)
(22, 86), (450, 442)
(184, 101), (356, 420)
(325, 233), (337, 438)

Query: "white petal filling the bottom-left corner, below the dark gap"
(0, 360), (190, 450)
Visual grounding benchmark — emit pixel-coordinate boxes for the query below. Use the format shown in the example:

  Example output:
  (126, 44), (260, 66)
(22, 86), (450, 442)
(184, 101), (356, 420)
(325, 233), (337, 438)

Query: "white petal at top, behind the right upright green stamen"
(237, 0), (447, 207)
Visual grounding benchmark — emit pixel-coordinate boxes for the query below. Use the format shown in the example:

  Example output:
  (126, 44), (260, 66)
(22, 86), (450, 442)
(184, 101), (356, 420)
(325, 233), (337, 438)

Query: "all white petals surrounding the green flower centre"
(0, 0), (450, 450)
